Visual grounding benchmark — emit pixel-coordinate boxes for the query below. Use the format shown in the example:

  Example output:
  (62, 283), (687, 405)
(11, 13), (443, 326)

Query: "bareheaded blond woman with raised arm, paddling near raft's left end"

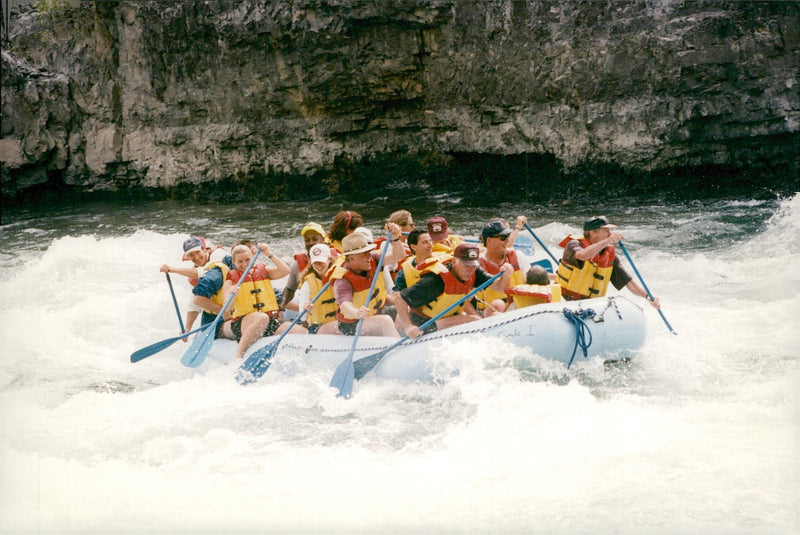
(221, 243), (306, 359)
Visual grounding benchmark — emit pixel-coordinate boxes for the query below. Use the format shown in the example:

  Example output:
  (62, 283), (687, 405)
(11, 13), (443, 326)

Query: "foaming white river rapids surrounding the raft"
(0, 195), (800, 533)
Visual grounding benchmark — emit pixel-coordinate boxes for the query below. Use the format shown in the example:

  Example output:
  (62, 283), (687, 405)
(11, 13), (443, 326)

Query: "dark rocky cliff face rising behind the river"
(0, 0), (800, 204)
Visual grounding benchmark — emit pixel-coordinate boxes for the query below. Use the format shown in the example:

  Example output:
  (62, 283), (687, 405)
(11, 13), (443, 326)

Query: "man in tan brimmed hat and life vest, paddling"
(330, 223), (406, 337)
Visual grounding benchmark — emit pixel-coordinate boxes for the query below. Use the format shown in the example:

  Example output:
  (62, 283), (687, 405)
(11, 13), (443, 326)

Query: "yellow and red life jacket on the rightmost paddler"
(556, 234), (615, 300)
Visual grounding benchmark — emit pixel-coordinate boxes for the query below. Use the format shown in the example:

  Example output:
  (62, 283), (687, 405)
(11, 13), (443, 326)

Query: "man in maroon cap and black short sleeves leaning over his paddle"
(395, 243), (513, 338)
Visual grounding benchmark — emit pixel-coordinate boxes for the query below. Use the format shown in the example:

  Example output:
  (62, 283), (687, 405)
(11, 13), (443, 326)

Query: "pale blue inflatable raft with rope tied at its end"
(207, 295), (645, 381)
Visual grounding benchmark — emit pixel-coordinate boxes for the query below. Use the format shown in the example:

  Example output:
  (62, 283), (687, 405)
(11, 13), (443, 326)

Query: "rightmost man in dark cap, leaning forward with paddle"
(556, 216), (661, 308)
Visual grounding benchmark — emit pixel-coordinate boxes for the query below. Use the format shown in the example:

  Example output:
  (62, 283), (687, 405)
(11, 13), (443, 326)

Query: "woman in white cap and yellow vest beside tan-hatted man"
(297, 243), (339, 334)
